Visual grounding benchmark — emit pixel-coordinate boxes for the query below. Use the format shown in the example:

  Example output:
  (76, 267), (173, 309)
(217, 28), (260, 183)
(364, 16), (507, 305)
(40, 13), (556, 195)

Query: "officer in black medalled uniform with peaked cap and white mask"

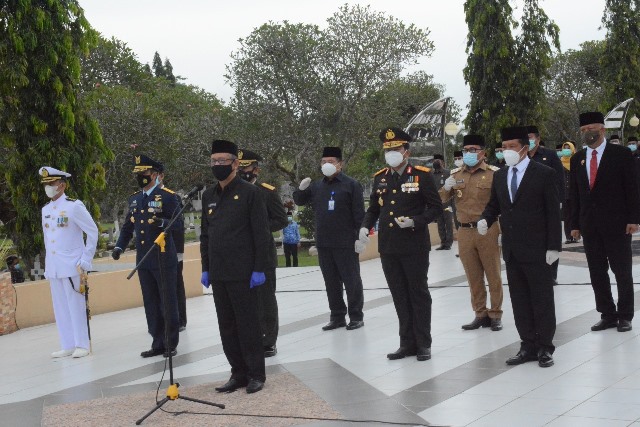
(360, 127), (442, 360)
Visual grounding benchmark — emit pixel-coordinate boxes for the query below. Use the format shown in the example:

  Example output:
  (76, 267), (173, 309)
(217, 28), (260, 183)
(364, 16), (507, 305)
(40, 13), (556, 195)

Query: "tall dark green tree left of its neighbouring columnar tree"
(463, 0), (517, 145)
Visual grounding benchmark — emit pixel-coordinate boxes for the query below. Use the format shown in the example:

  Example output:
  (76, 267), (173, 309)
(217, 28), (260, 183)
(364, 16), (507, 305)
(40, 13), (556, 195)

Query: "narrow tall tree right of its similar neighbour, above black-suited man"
(507, 0), (560, 127)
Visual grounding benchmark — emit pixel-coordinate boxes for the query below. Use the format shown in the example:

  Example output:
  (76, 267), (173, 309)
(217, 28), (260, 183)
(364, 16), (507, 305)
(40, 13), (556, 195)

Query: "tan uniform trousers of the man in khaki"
(458, 222), (503, 319)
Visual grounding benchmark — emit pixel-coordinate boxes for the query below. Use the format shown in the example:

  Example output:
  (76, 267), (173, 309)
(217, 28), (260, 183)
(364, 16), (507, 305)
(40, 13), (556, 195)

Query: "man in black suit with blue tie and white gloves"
(478, 127), (562, 368)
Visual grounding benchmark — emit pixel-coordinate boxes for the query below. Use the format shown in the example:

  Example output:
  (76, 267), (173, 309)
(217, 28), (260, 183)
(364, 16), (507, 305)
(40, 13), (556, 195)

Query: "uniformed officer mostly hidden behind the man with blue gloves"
(238, 150), (289, 357)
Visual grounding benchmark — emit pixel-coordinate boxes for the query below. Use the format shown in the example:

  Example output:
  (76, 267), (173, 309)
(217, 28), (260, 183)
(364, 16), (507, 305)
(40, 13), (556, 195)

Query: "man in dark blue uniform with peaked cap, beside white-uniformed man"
(111, 155), (182, 357)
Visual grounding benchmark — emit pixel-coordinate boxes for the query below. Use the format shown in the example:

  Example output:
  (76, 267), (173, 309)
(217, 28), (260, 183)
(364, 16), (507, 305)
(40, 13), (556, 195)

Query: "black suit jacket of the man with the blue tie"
(482, 161), (562, 263)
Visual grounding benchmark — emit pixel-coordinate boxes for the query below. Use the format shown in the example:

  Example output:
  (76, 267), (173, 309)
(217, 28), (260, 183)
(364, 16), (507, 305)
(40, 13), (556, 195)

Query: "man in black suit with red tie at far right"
(570, 112), (640, 332)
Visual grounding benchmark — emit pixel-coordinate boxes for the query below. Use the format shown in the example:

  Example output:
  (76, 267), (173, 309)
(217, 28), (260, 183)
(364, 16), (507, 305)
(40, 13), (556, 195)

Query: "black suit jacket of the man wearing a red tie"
(569, 144), (640, 234)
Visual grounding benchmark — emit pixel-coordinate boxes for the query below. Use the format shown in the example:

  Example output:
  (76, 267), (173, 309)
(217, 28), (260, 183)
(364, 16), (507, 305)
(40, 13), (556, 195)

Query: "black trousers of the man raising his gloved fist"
(318, 248), (364, 321)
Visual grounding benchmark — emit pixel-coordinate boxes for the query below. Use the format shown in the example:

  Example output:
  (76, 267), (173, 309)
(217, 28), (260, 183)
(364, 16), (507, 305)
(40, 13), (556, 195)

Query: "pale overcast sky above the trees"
(79, 0), (605, 117)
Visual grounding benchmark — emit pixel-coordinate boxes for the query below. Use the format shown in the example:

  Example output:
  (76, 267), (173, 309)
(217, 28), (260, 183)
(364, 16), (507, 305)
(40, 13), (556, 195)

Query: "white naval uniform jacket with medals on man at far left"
(42, 194), (98, 279)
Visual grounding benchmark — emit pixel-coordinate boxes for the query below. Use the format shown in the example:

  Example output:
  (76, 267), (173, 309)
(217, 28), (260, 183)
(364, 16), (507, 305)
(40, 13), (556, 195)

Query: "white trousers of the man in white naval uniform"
(49, 276), (89, 350)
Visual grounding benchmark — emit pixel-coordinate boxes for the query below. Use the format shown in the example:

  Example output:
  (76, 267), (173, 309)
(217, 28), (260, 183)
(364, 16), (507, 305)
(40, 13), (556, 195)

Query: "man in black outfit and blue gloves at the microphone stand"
(200, 140), (271, 393)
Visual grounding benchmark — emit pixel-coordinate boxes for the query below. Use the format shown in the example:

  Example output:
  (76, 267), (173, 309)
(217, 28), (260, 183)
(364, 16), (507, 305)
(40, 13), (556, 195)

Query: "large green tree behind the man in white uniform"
(0, 0), (111, 272)
